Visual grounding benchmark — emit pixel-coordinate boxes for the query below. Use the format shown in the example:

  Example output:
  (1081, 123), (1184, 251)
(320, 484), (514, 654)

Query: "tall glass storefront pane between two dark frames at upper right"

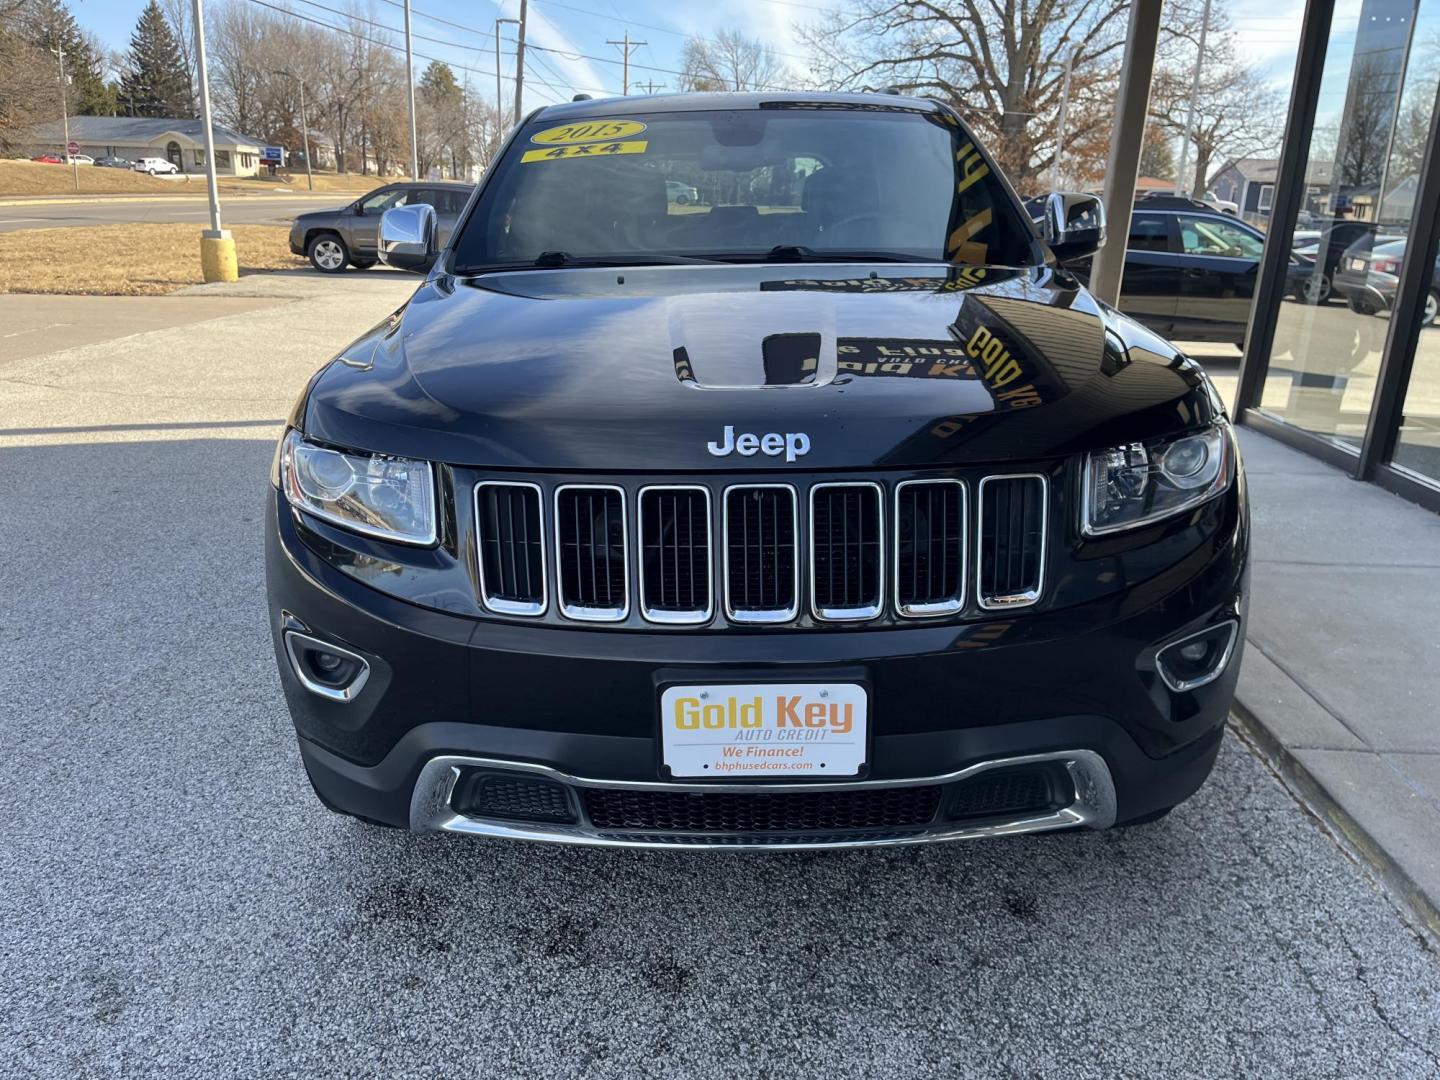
(1260, 0), (1440, 449)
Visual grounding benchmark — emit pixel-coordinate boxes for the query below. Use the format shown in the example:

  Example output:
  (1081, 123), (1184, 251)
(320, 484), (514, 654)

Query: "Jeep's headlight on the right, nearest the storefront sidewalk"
(1080, 423), (1234, 536)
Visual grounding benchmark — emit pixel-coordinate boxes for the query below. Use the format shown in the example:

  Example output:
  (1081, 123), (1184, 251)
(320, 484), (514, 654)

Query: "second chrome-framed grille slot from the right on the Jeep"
(891, 480), (969, 618)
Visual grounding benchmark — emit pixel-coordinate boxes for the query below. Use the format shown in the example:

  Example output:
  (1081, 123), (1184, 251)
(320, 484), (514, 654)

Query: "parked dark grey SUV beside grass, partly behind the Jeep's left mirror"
(289, 180), (475, 274)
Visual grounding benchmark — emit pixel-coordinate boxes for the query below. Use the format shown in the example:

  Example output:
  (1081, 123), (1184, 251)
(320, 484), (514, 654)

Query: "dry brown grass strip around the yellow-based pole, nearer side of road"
(0, 223), (305, 297)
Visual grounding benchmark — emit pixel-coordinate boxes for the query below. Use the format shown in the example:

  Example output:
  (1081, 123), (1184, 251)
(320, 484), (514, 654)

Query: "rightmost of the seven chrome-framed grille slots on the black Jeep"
(975, 472), (1050, 611)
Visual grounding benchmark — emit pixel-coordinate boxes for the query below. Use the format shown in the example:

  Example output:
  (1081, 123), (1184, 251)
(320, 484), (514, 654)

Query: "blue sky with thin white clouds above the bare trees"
(71, 0), (1319, 105)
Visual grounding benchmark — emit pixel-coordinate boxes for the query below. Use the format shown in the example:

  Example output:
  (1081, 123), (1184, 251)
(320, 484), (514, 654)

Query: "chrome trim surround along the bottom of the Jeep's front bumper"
(410, 750), (1115, 851)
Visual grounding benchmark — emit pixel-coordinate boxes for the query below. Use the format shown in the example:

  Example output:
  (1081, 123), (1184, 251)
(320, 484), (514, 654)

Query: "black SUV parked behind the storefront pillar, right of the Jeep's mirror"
(1073, 207), (1315, 346)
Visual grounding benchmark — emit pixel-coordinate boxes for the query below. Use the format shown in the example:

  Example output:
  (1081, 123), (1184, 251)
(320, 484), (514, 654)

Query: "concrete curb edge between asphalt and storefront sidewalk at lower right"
(1230, 700), (1440, 948)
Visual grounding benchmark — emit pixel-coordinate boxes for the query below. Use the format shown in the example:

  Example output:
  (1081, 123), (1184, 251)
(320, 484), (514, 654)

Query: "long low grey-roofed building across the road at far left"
(30, 117), (265, 176)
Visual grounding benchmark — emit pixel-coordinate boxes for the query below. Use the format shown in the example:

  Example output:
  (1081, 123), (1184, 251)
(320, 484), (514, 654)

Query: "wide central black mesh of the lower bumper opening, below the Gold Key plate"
(585, 786), (940, 834)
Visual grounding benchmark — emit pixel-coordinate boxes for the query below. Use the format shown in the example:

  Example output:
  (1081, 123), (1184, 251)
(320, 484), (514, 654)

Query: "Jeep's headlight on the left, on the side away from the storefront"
(279, 431), (435, 544)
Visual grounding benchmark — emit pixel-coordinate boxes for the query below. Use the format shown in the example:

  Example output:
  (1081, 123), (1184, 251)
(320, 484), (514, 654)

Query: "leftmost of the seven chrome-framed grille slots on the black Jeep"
(475, 481), (549, 618)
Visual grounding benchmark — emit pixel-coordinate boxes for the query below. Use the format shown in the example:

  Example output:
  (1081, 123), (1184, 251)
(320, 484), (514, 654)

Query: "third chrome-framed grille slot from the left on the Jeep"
(638, 484), (714, 625)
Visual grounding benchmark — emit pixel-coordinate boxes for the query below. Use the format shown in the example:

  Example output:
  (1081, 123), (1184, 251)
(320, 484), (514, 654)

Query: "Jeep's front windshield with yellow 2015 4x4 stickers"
(455, 102), (1032, 274)
